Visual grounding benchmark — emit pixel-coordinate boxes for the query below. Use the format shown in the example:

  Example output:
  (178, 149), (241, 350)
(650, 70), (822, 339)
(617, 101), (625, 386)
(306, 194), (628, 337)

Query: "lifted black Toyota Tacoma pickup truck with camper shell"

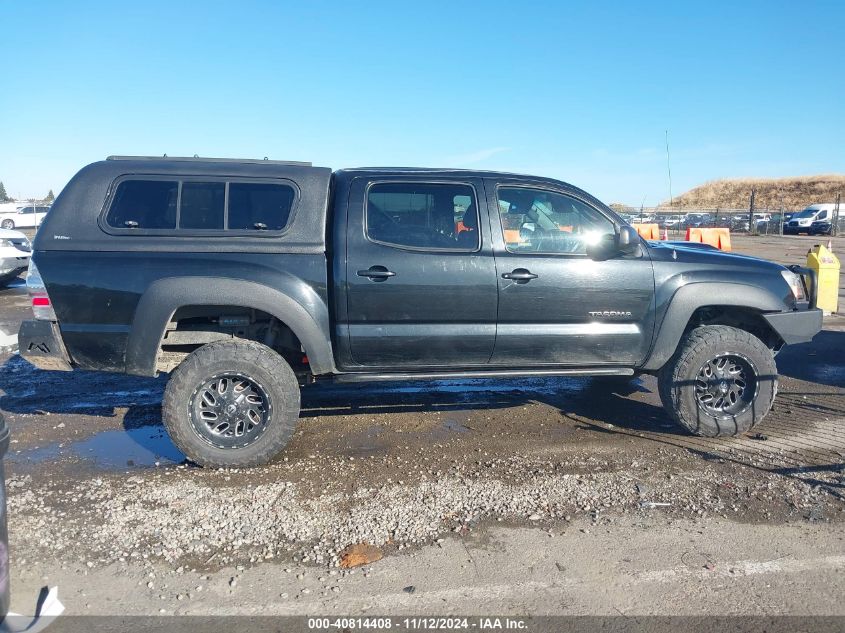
(19, 157), (822, 466)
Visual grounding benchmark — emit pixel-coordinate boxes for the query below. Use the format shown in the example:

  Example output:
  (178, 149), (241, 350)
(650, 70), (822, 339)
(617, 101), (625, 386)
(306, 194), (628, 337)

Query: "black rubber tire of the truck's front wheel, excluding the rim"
(657, 325), (777, 437)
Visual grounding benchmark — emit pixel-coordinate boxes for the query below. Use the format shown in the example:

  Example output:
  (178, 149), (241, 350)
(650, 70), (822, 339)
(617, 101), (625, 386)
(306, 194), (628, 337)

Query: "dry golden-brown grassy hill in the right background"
(661, 174), (845, 210)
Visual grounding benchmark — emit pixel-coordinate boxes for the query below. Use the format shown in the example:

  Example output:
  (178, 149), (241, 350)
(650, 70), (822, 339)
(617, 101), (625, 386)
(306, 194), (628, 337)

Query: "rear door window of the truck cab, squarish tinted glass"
(366, 183), (481, 252)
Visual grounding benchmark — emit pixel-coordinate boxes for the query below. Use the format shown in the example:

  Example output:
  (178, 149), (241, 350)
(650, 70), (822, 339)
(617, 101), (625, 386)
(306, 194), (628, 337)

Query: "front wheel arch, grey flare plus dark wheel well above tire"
(643, 282), (789, 371)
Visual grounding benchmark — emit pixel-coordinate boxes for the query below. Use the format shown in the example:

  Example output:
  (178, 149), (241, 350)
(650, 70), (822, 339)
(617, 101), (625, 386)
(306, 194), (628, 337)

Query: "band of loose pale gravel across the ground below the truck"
(9, 442), (845, 569)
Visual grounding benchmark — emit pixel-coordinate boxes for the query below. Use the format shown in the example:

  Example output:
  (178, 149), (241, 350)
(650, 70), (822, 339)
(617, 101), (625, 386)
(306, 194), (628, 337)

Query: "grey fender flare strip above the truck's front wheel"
(642, 282), (789, 370)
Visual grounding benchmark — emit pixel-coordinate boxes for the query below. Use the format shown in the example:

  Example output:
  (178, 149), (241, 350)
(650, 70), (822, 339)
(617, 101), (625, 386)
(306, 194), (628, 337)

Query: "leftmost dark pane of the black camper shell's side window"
(106, 180), (179, 229)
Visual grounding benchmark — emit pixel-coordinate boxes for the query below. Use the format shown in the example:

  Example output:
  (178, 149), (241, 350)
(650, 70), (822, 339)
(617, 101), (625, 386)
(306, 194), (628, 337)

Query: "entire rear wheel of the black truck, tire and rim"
(162, 341), (299, 468)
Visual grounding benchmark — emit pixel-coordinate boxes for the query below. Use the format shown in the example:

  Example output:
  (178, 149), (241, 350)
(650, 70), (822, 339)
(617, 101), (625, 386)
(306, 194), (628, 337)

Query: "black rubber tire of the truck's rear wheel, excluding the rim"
(162, 341), (299, 468)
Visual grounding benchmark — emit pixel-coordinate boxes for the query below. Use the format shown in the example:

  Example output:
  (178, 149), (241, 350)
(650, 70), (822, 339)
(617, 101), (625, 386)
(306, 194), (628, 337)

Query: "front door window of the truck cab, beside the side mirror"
(498, 187), (615, 255)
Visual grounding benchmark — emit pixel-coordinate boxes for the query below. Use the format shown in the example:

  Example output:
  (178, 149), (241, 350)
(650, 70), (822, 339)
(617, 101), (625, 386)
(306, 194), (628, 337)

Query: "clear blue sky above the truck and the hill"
(0, 0), (845, 205)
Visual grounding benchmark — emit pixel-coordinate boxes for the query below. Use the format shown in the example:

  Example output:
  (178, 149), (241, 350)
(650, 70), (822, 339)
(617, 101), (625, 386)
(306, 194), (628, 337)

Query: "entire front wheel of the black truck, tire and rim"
(658, 325), (778, 437)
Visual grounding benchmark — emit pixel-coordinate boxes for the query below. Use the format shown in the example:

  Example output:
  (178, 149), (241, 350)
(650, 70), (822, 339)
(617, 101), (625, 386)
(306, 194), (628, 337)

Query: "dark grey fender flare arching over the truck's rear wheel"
(126, 277), (335, 376)
